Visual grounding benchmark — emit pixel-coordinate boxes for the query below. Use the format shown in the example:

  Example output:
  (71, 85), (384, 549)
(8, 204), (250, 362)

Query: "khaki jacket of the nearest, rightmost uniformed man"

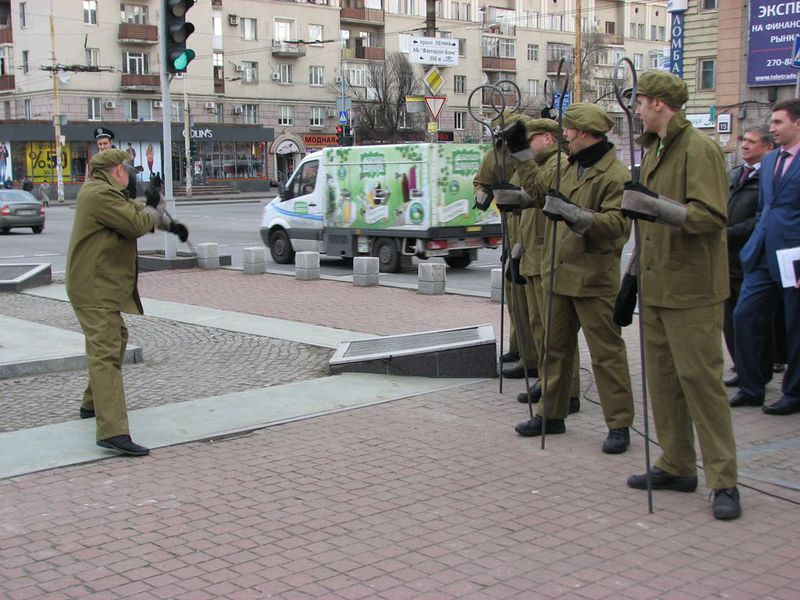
(637, 111), (730, 308)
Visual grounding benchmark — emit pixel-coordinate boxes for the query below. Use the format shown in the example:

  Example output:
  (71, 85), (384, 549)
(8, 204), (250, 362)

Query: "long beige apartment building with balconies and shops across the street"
(0, 0), (668, 189)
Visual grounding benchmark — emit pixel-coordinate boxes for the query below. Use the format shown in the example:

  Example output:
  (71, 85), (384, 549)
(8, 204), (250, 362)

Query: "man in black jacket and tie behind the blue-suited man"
(722, 125), (783, 398)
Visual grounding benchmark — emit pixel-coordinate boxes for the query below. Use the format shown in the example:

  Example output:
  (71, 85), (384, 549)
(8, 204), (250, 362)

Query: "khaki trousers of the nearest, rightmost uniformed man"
(644, 302), (736, 489)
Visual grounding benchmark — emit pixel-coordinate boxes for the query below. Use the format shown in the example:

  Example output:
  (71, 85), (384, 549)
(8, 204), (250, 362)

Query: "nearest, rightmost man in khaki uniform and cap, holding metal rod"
(622, 71), (741, 519)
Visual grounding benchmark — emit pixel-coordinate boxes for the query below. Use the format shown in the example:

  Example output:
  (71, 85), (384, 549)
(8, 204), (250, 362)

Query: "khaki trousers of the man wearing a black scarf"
(538, 294), (633, 429)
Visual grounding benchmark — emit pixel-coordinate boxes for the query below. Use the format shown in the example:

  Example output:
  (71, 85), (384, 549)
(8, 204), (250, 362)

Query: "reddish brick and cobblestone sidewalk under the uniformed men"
(0, 270), (800, 600)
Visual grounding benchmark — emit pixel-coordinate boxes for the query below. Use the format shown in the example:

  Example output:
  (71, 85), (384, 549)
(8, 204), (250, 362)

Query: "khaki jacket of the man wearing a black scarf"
(542, 148), (630, 298)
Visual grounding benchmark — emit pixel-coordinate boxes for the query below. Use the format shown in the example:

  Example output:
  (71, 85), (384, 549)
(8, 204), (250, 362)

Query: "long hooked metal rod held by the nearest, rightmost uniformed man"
(613, 57), (653, 514)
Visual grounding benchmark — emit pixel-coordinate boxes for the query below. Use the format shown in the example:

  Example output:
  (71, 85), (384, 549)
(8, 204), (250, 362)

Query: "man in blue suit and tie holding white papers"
(731, 99), (800, 415)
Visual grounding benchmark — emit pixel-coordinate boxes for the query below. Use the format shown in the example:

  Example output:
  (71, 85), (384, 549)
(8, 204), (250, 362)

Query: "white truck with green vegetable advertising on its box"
(261, 144), (502, 272)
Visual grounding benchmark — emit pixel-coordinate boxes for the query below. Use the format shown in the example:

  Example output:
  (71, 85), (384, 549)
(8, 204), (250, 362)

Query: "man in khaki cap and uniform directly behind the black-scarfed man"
(512, 118), (581, 414)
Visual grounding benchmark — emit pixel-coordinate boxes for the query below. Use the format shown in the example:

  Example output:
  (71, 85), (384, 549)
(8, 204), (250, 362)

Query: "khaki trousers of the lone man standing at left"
(74, 308), (129, 441)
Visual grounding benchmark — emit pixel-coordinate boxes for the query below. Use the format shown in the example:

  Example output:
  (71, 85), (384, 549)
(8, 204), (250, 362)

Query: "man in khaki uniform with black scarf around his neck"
(512, 103), (633, 454)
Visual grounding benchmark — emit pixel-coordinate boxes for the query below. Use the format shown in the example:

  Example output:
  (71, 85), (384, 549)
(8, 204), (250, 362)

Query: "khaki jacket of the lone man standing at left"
(66, 169), (155, 314)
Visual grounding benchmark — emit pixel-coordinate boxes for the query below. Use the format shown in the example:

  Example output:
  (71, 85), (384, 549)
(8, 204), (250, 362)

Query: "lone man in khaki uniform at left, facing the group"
(66, 149), (169, 456)
